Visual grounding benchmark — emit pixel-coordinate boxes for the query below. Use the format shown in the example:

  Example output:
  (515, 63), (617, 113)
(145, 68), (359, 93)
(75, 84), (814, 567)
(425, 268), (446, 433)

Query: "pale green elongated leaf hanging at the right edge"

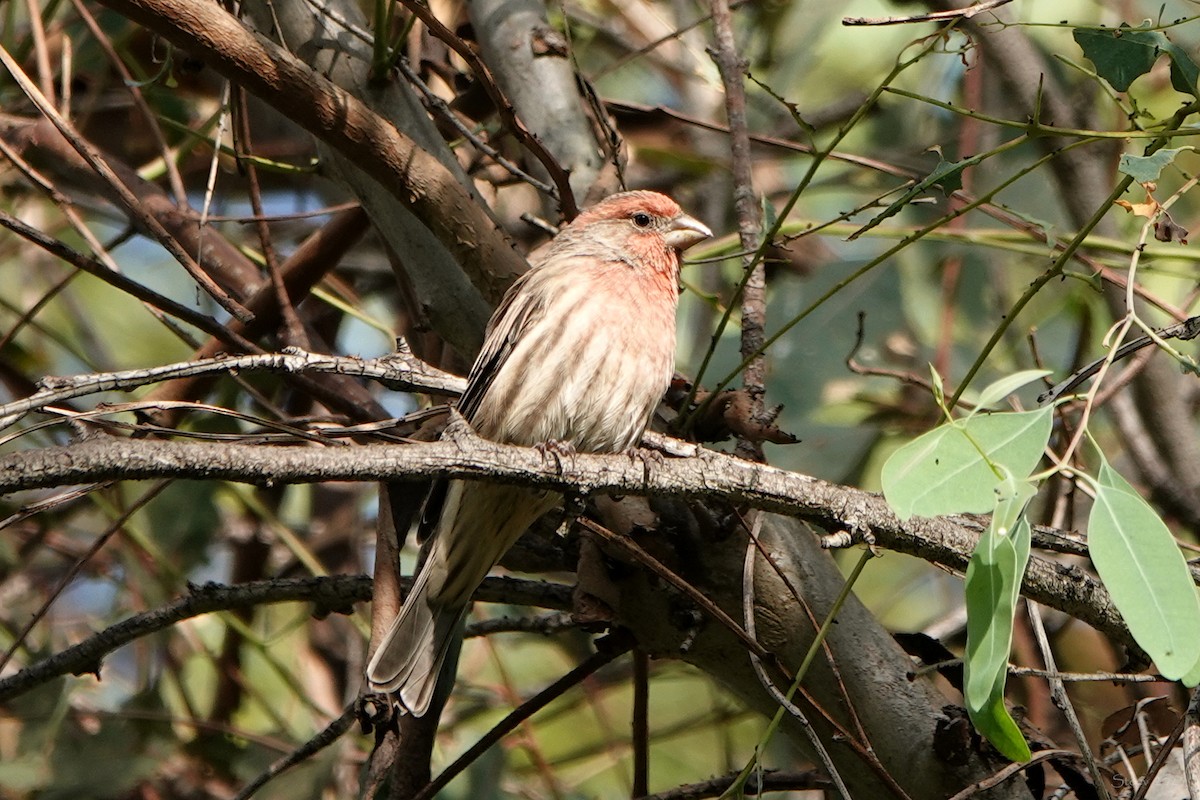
(1087, 462), (1200, 680)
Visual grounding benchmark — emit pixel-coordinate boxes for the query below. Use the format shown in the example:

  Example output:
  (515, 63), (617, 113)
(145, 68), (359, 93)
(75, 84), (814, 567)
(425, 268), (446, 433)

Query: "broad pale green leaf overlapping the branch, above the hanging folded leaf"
(881, 407), (1054, 519)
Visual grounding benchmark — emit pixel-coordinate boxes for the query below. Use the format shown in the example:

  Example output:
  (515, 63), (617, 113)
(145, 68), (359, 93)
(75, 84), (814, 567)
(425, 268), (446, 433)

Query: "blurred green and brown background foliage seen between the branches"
(0, 0), (1200, 799)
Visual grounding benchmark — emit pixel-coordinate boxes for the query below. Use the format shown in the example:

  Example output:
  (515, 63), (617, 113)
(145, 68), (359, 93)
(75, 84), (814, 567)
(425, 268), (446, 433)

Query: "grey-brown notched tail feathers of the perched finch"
(367, 553), (467, 716)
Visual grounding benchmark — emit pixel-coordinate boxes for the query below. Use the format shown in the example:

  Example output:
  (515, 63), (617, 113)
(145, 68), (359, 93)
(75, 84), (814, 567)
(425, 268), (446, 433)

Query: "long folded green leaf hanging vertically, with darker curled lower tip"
(962, 475), (1037, 762)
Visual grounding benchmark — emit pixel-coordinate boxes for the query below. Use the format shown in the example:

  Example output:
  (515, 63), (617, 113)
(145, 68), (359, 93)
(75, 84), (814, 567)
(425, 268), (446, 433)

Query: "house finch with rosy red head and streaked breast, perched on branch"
(367, 192), (713, 716)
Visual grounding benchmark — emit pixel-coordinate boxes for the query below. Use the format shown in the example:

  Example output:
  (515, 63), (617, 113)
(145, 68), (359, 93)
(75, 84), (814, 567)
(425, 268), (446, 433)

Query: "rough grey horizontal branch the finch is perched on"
(0, 425), (1132, 645)
